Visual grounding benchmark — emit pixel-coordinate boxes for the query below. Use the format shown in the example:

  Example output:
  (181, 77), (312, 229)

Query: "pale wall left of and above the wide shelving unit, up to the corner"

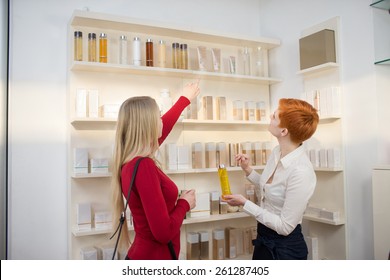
(8, 0), (260, 259)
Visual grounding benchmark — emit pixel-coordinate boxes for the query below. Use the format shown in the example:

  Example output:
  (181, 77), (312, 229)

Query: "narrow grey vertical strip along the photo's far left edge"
(0, 1), (8, 260)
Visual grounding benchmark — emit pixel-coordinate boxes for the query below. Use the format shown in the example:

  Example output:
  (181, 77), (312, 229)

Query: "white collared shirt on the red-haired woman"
(243, 145), (317, 235)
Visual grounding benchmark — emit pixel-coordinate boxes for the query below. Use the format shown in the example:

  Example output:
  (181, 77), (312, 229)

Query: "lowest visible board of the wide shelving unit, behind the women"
(72, 212), (250, 237)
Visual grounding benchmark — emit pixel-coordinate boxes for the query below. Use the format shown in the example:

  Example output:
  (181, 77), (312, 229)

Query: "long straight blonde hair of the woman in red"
(112, 96), (161, 252)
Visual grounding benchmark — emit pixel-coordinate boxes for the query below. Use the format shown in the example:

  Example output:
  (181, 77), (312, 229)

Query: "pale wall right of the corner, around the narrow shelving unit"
(261, 0), (390, 259)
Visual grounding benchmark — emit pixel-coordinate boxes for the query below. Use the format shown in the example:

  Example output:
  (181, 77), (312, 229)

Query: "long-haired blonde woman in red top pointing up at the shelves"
(113, 82), (200, 260)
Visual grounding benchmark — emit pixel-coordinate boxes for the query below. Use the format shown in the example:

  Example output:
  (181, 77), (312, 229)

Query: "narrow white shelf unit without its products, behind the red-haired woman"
(298, 17), (348, 260)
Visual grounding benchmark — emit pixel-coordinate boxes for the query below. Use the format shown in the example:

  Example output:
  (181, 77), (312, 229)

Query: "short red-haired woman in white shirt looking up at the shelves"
(224, 98), (319, 259)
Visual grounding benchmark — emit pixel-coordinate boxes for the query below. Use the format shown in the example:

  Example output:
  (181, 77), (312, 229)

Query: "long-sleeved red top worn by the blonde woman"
(121, 96), (190, 260)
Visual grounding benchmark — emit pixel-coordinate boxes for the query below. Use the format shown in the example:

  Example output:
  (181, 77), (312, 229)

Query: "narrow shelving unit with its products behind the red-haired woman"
(297, 17), (348, 259)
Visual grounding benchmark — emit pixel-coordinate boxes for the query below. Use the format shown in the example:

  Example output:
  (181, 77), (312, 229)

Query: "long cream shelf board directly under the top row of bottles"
(70, 61), (282, 85)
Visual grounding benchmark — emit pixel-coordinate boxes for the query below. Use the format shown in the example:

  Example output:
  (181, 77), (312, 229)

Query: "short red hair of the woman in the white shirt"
(279, 98), (319, 143)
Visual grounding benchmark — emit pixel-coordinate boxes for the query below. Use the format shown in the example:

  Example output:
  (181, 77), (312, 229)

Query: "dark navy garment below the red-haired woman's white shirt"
(252, 223), (308, 260)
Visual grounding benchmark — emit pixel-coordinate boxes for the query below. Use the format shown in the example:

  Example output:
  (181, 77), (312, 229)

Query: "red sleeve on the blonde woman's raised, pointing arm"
(158, 96), (191, 145)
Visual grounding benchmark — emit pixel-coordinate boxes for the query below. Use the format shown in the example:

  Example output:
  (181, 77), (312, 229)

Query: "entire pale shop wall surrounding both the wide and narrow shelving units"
(8, 0), (390, 259)
